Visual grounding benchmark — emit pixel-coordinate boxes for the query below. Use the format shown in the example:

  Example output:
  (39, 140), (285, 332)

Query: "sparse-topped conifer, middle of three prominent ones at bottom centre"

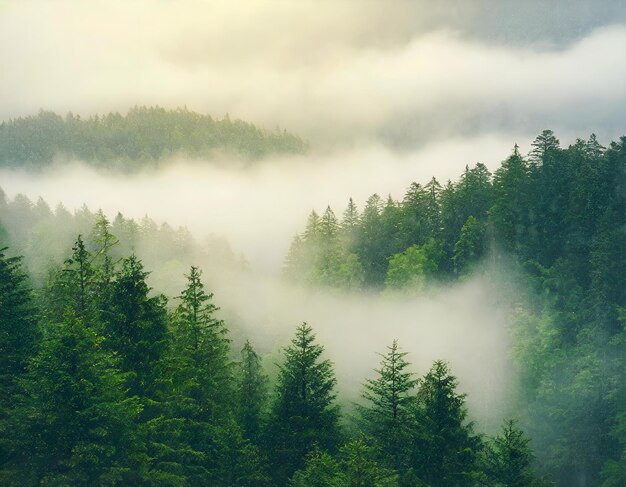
(359, 340), (417, 470)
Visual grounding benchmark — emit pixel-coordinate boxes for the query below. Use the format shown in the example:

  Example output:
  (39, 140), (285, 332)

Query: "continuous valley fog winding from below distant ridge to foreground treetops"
(0, 135), (528, 428)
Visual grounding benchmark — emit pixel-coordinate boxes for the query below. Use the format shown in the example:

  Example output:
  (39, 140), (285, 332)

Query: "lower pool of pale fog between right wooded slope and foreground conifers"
(216, 269), (517, 432)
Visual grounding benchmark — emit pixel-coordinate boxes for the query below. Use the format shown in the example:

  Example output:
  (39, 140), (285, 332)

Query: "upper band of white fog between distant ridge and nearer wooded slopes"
(0, 135), (528, 274)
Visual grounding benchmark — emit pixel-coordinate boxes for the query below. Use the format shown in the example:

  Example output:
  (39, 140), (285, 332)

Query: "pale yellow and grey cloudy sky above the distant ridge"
(0, 0), (626, 149)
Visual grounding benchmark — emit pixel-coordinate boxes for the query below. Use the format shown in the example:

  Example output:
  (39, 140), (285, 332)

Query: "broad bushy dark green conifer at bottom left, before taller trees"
(11, 313), (140, 485)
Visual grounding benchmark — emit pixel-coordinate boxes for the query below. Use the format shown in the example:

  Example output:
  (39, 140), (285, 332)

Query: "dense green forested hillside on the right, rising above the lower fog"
(285, 130), (626, 485)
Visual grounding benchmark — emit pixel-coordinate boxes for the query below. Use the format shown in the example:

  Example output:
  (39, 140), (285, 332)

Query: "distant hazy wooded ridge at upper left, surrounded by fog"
(0, 107), (307, 169)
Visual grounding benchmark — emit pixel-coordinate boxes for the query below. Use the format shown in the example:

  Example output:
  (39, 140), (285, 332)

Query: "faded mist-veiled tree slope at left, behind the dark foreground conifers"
(0, 193), (247, 294)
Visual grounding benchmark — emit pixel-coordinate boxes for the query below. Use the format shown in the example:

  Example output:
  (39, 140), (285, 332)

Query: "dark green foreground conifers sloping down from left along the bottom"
(0, 219), (539, 486)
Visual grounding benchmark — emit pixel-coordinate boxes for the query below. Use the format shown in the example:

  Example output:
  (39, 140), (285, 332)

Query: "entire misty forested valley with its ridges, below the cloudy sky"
(0, 107), (626, 487)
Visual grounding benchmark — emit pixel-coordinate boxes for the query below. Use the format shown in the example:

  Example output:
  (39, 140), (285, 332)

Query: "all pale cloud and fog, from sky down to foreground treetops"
(0, 0), (626, 434)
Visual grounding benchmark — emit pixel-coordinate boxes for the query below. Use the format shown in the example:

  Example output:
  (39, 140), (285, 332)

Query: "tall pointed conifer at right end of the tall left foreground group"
(148, 266), (243, 485)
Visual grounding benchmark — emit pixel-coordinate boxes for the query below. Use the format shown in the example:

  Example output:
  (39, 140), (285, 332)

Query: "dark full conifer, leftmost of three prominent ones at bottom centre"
(265, 323), (339, 484)
